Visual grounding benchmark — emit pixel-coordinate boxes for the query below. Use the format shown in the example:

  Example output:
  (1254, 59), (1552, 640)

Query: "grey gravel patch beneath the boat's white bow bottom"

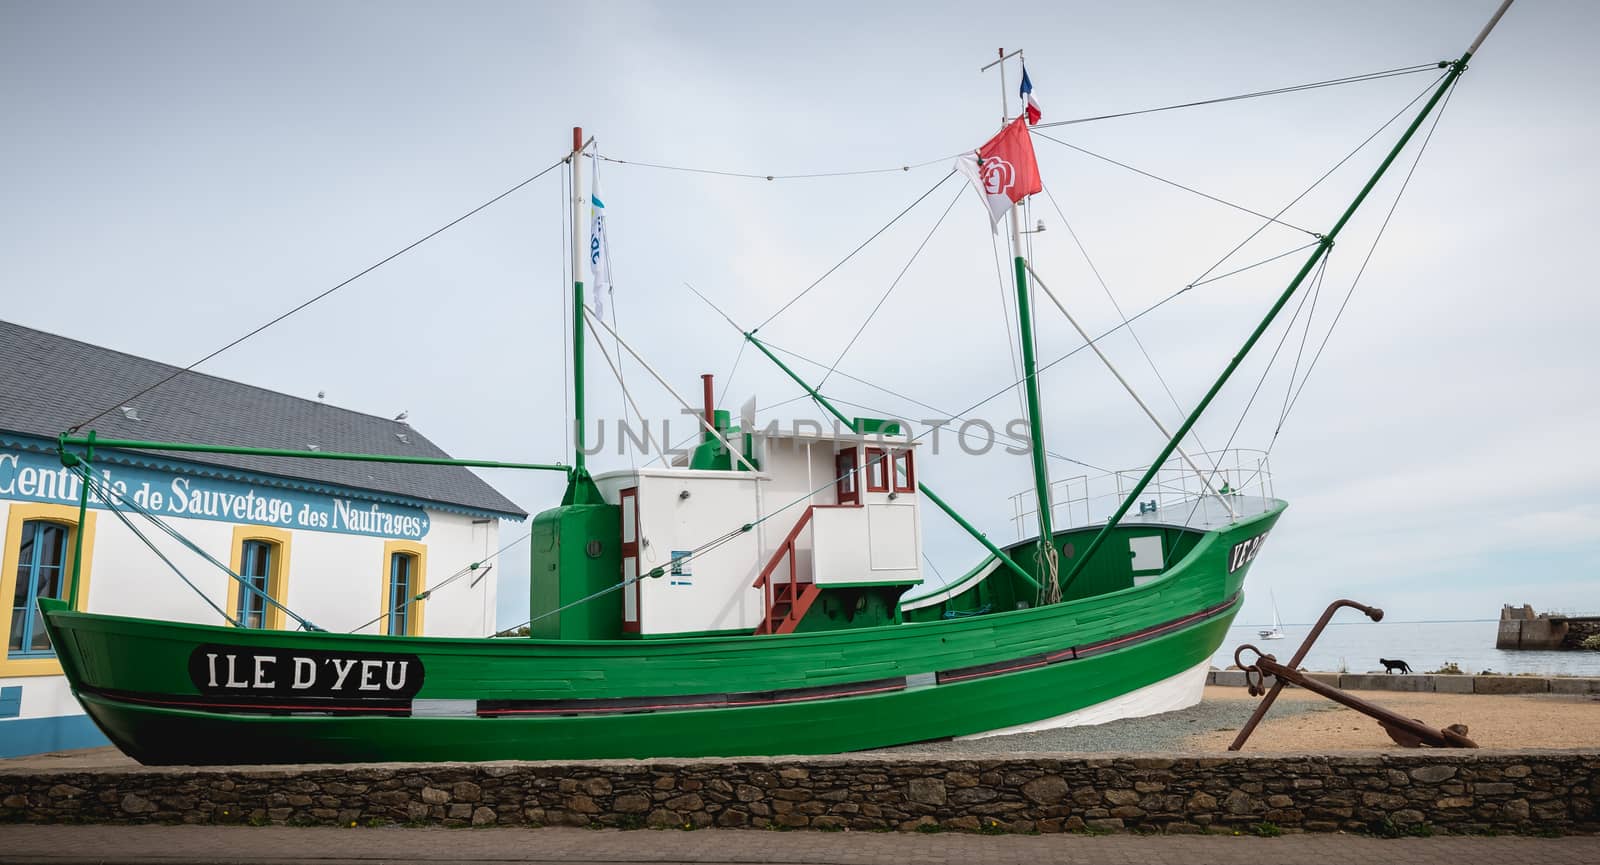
(867, 690), (1339, 755)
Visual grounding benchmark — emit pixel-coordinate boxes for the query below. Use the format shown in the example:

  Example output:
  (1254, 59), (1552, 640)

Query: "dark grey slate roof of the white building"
(0, 321), (528, 518)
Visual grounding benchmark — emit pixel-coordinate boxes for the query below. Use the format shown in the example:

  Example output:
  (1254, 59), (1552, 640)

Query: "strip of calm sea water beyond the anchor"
(1211, 611), (1600, 676)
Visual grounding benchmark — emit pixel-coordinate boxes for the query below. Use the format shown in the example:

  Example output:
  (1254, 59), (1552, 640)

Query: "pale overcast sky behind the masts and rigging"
(0, 0), (1600, 624)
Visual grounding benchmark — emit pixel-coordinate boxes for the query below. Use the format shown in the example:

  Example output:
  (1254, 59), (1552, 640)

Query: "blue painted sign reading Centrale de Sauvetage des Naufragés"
(0, 449), (429, 540)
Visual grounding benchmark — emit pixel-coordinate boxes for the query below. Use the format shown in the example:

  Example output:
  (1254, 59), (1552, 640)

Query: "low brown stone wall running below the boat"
(0, 751), (1600, 833)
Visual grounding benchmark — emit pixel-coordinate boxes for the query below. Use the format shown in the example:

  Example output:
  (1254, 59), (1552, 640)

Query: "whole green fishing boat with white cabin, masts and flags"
(38, 6), (1504, 764)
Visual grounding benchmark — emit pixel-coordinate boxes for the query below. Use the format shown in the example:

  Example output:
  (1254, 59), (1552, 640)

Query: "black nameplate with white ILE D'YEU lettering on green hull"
(189, 644), (422, 700)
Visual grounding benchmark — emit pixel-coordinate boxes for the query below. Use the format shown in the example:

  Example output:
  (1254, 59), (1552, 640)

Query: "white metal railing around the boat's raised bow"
(1011, 448), (1275, 539)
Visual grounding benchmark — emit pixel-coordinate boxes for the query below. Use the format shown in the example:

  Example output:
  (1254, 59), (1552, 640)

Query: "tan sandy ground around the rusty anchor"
(1182, 686), (1600, 751)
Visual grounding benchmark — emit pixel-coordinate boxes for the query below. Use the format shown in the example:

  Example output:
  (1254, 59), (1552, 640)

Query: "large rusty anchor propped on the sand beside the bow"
(1227, 598), (1478, 751)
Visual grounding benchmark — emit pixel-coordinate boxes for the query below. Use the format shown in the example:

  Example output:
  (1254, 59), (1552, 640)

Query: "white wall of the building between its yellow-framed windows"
(0, 473), (501, 756)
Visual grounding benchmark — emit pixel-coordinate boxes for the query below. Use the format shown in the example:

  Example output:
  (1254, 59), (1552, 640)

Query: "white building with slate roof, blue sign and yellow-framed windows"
(0, 321), (526, 756)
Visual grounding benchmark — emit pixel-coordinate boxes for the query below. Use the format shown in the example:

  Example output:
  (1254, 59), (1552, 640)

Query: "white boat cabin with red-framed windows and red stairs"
(595, 424), (922, 636)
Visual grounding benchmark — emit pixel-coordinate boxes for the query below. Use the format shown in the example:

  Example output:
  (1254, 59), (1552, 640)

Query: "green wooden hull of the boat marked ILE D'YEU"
(46, 504), (1283, 764)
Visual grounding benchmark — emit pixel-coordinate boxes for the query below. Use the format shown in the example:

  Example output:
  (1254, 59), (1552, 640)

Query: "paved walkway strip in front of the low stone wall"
(0, 825), (1600, 865)
